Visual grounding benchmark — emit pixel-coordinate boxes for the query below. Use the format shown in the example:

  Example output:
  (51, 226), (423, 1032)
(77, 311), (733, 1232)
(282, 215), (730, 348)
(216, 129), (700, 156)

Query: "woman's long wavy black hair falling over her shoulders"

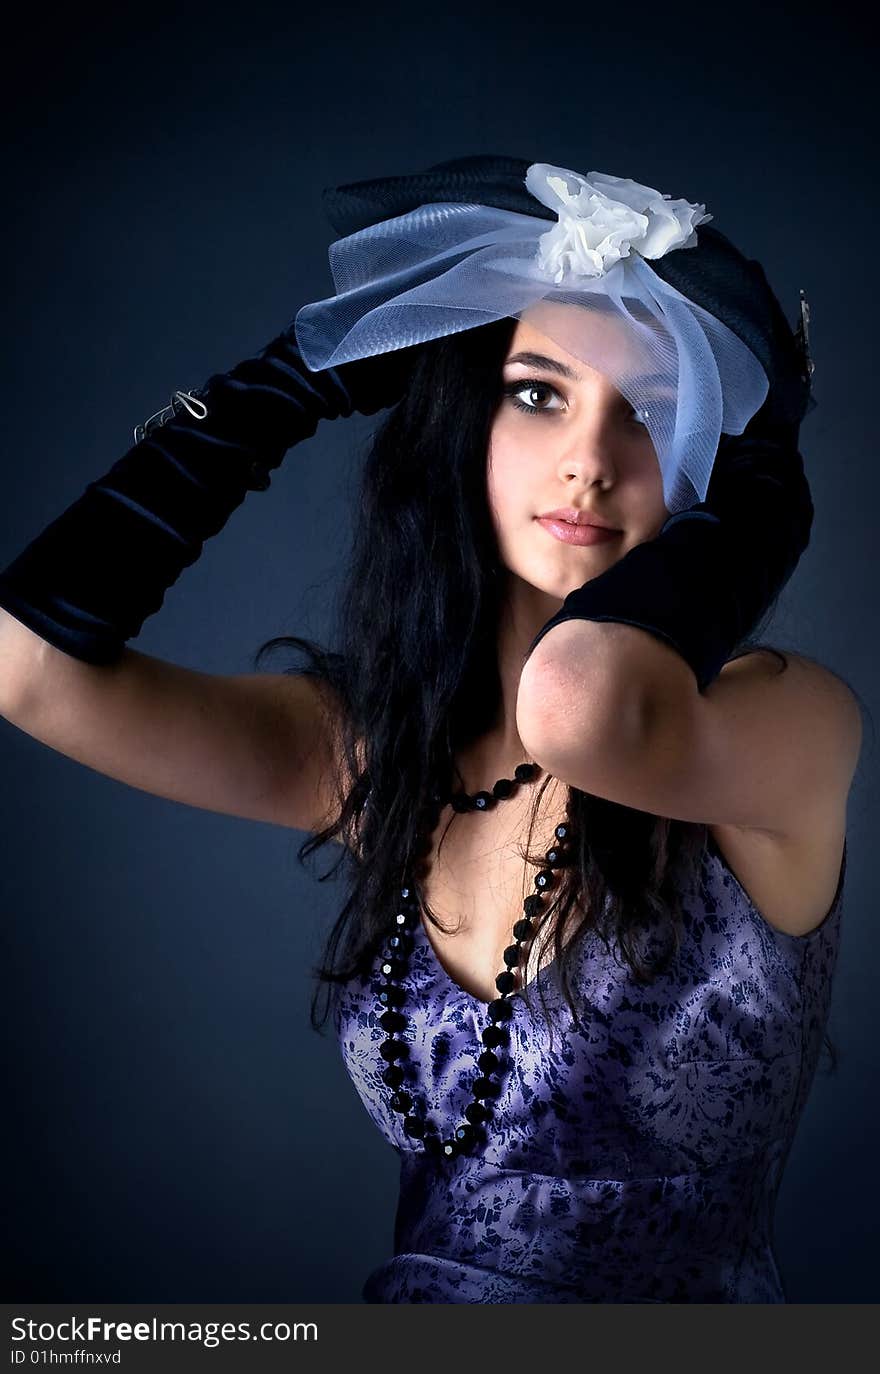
(254, 319), (847, 1066)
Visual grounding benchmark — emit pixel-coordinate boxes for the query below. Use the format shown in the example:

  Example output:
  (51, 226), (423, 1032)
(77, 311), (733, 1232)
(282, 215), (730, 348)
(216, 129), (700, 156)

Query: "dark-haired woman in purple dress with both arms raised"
(0, 159), (861, 1303)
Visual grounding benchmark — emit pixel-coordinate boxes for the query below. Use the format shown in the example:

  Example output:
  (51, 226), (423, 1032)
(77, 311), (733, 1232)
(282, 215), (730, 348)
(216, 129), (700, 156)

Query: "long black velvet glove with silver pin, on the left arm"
(0, 327), (413, 664)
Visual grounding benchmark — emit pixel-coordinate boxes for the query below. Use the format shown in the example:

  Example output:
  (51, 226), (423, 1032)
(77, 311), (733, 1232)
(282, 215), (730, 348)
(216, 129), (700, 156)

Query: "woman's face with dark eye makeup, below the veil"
(487, 306), (670, 599)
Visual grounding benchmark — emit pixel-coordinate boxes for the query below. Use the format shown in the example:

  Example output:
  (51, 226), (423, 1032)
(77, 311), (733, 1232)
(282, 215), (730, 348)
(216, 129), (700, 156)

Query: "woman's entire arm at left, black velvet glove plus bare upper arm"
(0, 305), (410, 830)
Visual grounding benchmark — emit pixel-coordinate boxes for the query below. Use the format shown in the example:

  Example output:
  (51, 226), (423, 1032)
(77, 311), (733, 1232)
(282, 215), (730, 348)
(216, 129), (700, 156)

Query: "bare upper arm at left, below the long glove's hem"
(0, 610), (343, 831)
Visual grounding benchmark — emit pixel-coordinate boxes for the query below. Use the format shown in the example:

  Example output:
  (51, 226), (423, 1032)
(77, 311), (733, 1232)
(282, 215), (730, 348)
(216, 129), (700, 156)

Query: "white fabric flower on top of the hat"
(525, 162), (714, 286)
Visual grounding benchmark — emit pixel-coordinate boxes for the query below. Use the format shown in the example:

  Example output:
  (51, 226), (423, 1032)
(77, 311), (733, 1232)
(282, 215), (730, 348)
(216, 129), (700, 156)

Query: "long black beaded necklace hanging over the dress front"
(378, 763), (572, 1160)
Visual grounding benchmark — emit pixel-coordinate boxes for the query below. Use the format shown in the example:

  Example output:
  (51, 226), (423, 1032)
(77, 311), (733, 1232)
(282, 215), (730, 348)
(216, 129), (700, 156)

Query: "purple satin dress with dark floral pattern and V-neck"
(334, 831), (847, 1303)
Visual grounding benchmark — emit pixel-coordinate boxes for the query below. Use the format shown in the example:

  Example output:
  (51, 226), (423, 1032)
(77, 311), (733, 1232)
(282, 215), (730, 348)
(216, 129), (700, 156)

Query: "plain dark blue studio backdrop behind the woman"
(0, 0), (880, 1303)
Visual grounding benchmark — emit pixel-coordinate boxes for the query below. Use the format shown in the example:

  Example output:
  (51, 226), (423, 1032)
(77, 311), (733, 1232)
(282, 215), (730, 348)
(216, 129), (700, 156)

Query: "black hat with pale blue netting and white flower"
(294, 155), (814, 513)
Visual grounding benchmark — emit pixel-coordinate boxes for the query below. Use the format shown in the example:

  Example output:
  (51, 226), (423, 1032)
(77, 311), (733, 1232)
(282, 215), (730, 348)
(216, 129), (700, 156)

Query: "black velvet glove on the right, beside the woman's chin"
(527, 397), (813, 692)
